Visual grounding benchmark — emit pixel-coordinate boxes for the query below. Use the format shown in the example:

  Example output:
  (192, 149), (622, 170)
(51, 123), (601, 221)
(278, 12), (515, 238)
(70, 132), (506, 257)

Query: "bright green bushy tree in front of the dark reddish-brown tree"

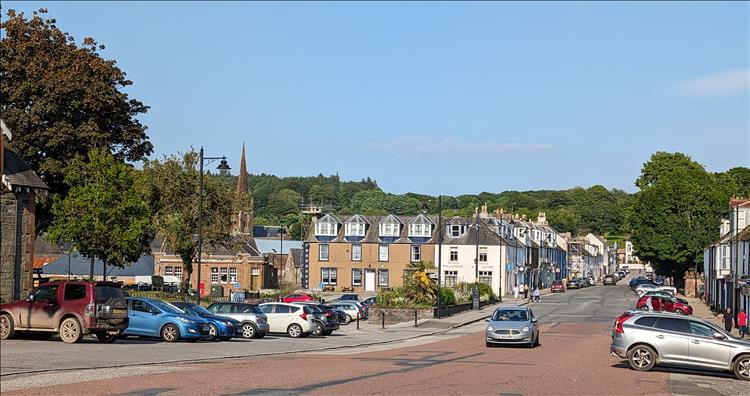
(47, 150), (154, 277)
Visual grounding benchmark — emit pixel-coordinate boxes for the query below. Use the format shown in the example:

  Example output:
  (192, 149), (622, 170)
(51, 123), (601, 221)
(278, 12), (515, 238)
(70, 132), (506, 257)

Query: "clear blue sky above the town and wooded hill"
(3, 1), (750, 195)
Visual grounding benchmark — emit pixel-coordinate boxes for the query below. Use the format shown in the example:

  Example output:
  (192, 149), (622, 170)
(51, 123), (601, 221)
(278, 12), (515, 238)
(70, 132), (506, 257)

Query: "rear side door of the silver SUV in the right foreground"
(644, 317), (692, 362)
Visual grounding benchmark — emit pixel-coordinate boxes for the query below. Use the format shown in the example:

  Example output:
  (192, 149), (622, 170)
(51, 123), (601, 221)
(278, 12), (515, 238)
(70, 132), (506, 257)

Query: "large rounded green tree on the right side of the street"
(628, 152), (729, 280)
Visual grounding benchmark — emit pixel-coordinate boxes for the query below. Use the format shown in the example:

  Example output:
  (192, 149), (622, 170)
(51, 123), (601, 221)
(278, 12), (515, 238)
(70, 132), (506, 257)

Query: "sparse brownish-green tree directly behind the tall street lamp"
(143, 150), (233, 291)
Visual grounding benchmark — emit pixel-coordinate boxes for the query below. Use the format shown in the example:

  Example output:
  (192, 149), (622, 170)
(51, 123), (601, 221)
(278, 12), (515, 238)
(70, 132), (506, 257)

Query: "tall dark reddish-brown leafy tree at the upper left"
(0, 9), (153, 230)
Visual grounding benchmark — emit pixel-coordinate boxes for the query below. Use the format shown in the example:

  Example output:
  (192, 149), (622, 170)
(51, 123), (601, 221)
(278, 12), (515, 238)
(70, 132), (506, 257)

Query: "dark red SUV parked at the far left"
(0, 281), (128, 343)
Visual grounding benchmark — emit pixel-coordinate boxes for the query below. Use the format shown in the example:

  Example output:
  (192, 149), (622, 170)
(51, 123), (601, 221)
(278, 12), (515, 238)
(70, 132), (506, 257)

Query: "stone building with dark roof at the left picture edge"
(0, 120), (47, 302)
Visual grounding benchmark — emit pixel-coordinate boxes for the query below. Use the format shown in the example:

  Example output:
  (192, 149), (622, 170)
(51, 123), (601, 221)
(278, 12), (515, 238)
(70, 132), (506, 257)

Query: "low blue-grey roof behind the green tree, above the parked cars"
(42, 252), (154, 276)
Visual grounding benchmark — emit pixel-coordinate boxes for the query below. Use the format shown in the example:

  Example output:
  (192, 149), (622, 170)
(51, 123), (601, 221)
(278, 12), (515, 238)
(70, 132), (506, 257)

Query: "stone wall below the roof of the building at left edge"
(0, 191), (36, 302)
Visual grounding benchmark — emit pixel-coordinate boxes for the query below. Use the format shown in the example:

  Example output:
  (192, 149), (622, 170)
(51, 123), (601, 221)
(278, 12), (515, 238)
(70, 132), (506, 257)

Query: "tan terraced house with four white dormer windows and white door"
(302, 214), (437, 292)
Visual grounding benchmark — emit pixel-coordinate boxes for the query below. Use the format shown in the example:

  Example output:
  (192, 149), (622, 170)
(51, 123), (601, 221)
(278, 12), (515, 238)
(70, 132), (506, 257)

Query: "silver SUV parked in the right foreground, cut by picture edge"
(609, 311), (750, 381)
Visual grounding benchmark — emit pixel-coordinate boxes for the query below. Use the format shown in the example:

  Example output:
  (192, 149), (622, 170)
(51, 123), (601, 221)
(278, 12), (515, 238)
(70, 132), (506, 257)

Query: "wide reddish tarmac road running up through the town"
(1, 284), (750, 396)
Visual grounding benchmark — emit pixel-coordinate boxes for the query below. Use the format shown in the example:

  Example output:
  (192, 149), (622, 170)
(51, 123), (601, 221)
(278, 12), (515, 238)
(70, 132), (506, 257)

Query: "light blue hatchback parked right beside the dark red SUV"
(123, 297), (210, 342)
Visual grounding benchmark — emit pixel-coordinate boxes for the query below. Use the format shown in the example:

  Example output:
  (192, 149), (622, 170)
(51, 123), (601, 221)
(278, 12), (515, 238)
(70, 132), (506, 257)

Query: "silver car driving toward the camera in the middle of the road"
(485, 307), (539, 348)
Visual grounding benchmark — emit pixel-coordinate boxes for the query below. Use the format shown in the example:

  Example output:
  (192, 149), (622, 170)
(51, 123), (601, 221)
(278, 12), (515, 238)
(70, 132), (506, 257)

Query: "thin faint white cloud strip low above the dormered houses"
(364, 135), (554, 154)
